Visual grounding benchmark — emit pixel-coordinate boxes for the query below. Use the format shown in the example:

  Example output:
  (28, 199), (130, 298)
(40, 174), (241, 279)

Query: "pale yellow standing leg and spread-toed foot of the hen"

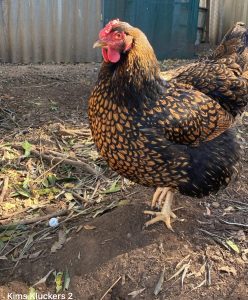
(144, 188), (177, 231)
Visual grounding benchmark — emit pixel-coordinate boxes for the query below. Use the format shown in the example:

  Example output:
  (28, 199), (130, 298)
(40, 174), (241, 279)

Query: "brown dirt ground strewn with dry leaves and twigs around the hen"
(0, 61), (248, 300)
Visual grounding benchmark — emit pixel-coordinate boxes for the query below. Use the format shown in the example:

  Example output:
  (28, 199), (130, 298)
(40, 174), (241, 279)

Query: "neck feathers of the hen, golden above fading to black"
(99, 41), (166, 107)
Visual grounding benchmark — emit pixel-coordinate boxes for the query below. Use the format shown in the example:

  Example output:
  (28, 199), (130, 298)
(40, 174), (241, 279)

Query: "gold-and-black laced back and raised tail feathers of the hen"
(161, 22), (248, 117)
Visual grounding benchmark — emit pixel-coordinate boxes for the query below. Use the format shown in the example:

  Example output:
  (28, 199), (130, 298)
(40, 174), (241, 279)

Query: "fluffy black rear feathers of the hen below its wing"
(178, 130), (243, 197)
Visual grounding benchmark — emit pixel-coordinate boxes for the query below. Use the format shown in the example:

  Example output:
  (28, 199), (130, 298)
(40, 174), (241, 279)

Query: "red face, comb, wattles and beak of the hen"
(93, 19), (133, 63)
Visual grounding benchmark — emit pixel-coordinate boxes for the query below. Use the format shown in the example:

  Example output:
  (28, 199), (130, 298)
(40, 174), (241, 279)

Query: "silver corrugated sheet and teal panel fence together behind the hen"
(0, 0), (199, 63)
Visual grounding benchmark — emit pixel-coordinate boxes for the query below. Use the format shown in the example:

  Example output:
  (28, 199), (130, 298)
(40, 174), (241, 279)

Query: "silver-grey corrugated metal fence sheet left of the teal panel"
(0, 0), (102, 63)
